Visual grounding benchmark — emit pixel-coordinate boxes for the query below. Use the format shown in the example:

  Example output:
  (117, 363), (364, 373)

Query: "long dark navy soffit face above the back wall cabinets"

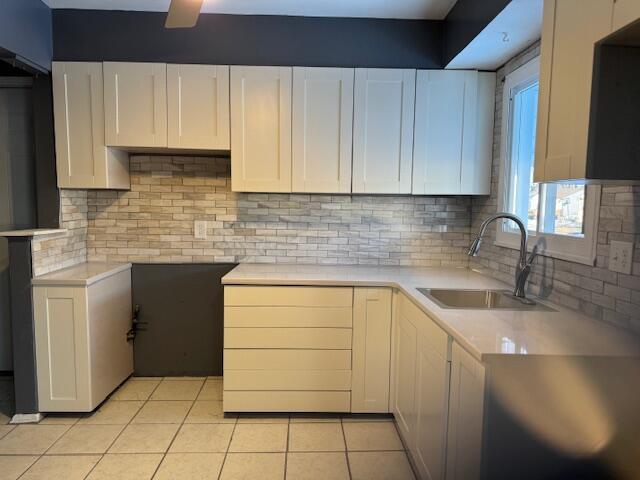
(53, 10), (443, 68)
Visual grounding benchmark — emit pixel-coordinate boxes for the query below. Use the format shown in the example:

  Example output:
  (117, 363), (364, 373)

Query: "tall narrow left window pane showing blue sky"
(504, 82), (540, 232)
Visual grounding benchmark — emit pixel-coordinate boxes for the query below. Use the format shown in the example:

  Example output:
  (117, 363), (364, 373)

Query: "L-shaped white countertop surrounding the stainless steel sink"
(222, 264), (640, 361)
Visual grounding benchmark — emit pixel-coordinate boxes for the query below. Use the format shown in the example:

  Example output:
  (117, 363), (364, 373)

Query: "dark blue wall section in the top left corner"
(0, 0), (52, 70)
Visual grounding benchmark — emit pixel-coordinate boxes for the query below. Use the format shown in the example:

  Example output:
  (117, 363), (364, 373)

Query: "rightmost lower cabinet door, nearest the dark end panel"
(446, 343), (484, 480)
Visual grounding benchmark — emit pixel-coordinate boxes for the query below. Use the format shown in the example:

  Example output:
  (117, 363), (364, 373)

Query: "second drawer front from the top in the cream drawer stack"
(224, 307), (352, 328)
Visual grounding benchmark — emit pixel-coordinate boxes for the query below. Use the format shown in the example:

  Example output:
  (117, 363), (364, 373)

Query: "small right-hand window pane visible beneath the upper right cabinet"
(540, 184), (586, 237)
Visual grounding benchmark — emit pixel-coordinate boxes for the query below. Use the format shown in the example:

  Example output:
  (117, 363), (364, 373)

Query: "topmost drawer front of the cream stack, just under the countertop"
(224, 287), (353, 307)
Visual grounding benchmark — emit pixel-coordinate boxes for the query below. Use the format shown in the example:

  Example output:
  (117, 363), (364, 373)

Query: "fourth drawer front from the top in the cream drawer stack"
(224, 349), (351, 371)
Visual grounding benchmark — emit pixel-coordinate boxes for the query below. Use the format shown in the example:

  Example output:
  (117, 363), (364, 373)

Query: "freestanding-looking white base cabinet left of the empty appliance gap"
(33, 265), (133, 412)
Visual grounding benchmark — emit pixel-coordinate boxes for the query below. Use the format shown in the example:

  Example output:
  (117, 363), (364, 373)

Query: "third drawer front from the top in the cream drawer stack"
(224, 328), (351, 350)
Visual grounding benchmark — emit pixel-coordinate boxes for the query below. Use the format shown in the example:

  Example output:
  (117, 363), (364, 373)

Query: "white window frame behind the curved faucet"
(495, 57), (600, 266)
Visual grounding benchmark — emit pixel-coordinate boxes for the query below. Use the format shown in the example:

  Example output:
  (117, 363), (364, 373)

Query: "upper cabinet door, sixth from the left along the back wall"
(352, 68), (416, 193)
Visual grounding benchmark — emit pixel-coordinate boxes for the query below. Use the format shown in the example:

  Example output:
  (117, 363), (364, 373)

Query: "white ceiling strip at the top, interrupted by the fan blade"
(42, 0), (456, 20)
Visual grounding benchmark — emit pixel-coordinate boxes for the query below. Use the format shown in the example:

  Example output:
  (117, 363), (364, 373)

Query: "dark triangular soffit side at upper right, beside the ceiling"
(443, 0), (511, 65)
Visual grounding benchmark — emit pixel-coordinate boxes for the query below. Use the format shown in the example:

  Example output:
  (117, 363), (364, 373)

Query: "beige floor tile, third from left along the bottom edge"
(87, 454), (162, 480)
